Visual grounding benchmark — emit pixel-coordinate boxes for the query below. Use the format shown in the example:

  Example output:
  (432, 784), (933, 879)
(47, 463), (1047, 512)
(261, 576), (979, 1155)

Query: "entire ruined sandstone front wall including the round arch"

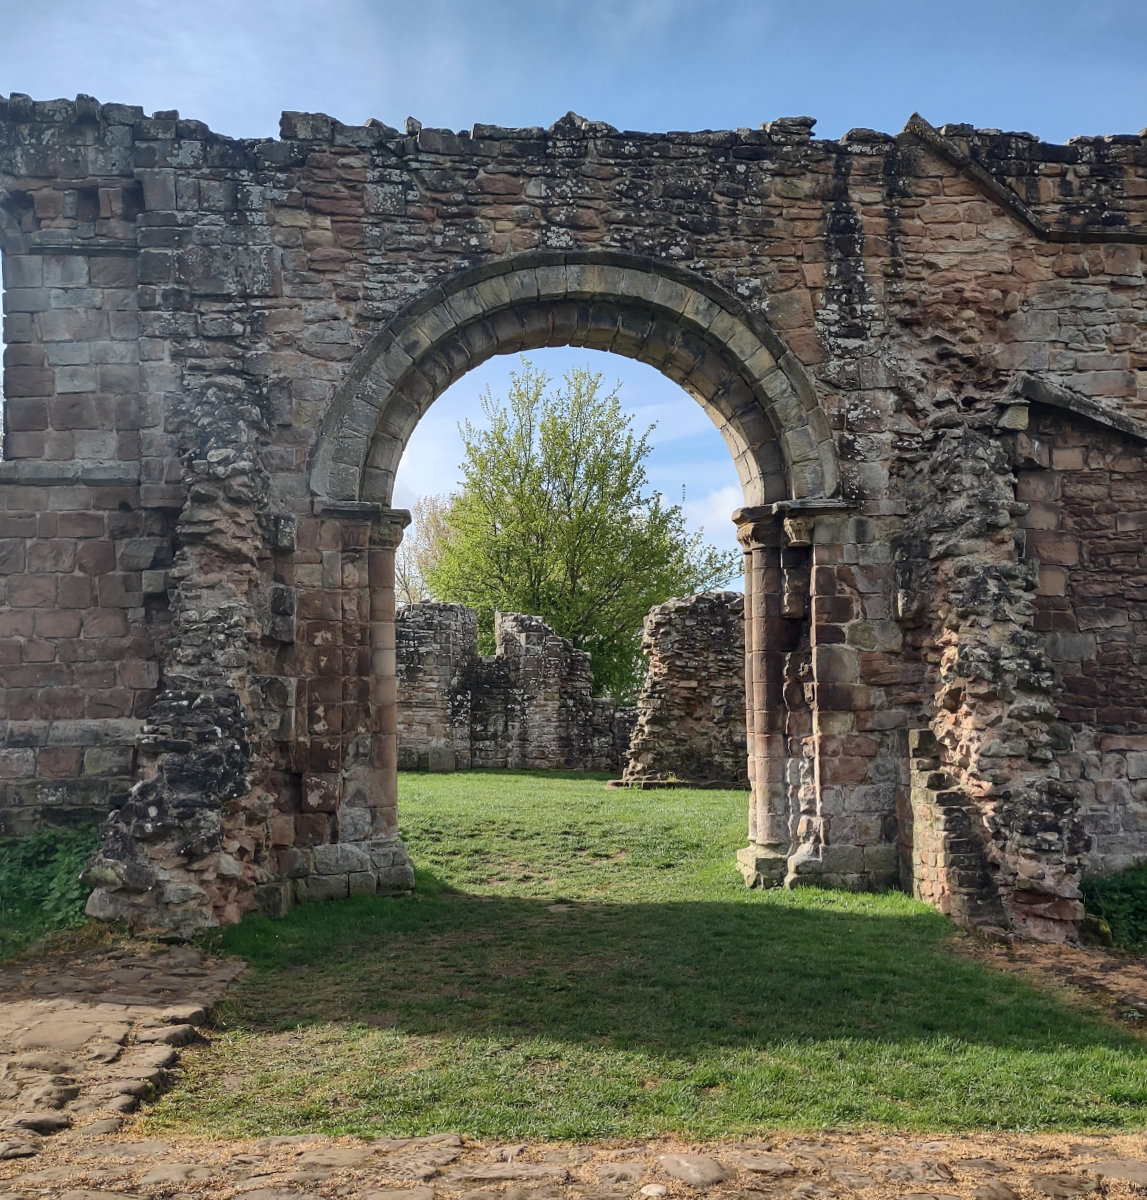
(0, 95), (1147, 938)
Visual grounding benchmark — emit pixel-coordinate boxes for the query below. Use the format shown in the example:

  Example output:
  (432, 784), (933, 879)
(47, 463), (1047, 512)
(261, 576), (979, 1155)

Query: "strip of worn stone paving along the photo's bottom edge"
(0, 1121), (1147, 1200)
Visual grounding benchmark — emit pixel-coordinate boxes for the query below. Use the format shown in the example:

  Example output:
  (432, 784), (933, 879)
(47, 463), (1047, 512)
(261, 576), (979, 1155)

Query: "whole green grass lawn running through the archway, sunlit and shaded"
(146, 772), (1147, 1140)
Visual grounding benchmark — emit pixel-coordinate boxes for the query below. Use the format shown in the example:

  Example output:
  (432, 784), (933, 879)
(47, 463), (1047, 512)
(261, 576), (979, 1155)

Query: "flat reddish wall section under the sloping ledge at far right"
(1013, 407), (1147, 874)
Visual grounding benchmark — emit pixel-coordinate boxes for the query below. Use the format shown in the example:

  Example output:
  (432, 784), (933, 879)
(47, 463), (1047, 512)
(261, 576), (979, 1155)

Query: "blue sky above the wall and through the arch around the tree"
(0, 0), (1147, 561)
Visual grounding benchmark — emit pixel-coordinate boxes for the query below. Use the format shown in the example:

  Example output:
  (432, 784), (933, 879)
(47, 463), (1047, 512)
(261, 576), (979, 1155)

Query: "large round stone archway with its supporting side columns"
(311, 252), (896, 887)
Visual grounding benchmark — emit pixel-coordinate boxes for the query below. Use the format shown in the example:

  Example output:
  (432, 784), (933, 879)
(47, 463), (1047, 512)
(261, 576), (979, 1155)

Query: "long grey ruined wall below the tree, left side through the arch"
(395, 602), (625, 772)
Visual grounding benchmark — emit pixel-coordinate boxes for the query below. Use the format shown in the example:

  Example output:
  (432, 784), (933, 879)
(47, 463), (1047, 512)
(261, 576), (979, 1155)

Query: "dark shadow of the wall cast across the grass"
(217, 872), (1136, 1056)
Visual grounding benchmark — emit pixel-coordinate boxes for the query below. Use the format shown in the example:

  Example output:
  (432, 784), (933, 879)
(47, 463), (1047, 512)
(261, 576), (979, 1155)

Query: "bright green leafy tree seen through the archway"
(425, 359), (740, 698)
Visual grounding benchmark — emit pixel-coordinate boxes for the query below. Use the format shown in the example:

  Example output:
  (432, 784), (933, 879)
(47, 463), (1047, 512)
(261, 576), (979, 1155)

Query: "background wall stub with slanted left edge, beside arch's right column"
(623, 592), (749, 787)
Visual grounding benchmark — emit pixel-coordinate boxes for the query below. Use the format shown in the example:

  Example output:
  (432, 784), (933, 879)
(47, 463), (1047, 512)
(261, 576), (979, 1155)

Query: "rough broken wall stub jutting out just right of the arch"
(900, 426), (1085, 941)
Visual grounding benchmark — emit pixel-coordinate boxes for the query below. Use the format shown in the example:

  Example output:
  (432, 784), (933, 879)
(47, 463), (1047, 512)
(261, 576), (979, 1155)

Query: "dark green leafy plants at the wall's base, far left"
(0, 826), (97, 959)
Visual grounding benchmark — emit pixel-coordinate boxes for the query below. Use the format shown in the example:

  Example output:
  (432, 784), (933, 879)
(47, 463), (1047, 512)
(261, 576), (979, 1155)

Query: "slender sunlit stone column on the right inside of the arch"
(733, 505), (791, 887)
